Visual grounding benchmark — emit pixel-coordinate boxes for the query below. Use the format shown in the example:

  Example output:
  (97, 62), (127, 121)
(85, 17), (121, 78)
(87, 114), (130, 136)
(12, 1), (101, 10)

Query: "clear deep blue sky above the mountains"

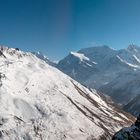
(0, 0), (140, 60)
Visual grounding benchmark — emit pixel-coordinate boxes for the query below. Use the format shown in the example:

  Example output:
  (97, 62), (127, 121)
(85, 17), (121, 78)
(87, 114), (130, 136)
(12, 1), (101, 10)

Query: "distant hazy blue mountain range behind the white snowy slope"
(58, 45), (140, 104)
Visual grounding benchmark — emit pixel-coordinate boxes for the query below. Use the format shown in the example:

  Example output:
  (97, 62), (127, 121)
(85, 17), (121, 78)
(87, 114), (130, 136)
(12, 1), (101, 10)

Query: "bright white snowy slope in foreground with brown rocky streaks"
(0, 47), (134, 140)
